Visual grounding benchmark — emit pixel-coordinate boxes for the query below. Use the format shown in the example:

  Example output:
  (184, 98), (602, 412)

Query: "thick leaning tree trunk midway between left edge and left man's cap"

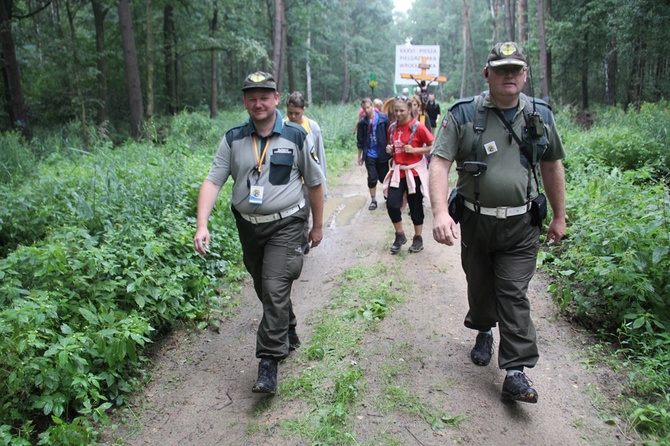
(118, 0), (144, 138)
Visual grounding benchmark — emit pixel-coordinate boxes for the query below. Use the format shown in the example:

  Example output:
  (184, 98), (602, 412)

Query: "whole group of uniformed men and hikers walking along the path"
(193, 42), (566, 403)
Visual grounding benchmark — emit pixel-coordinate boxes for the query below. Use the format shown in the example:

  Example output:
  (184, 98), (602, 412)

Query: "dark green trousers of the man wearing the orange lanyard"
(233, 208), (309, 360)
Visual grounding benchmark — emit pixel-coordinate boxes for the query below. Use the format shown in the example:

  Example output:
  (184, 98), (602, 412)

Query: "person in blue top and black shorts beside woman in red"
(356, 98), (392, 211)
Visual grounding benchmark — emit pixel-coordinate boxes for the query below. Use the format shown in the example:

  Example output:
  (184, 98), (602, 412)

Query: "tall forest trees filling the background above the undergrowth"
(0, 0), (670, 137)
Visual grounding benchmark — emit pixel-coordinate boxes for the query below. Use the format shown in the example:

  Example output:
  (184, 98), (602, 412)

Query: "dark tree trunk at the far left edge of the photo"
(0, 0), (33, 140)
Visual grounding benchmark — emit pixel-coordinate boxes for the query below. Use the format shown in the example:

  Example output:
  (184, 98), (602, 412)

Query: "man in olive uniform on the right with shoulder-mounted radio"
(430, 42), (566, 403)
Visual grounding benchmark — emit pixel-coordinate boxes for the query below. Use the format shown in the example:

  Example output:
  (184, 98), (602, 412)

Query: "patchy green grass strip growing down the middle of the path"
(249, 264), (459, 445)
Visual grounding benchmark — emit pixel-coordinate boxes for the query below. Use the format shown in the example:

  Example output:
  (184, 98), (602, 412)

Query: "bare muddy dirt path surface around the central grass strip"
(106, 166), (634, 446)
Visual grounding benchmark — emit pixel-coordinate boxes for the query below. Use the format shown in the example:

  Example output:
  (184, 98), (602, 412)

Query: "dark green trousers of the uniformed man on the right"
(461, 208), (540, 369)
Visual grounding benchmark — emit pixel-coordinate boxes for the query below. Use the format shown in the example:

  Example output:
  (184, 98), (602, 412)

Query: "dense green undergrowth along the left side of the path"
(0, 105), (362, 445)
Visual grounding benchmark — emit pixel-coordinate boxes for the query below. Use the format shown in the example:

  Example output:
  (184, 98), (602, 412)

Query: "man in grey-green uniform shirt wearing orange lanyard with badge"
(193, 72), (325, 394)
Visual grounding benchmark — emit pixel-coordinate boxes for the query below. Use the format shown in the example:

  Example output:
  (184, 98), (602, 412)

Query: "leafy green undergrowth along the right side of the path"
(543, 101), (670, 445)
